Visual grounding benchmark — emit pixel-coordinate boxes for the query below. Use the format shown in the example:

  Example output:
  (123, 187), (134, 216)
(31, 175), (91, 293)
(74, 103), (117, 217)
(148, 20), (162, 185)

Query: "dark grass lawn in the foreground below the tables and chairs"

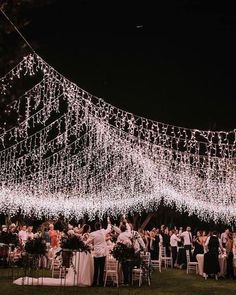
(0, 269), (236, 295)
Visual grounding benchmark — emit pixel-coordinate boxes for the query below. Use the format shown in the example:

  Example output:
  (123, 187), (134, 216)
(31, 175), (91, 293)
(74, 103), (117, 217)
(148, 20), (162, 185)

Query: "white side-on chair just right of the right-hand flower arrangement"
(132, 252), (151, 287)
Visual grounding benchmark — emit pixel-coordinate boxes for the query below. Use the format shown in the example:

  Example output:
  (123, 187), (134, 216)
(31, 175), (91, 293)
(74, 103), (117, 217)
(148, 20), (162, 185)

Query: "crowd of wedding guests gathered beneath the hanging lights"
(0, 217), (236, 286)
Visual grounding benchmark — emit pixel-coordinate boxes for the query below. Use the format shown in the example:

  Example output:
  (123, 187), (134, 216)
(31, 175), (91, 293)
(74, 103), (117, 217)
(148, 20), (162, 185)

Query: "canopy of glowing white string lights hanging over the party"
(0, 54), (236, 222)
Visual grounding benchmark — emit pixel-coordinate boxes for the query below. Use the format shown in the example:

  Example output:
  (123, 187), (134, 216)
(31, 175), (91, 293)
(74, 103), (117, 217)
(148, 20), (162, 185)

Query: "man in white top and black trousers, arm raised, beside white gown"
(87, 222), (111, 287)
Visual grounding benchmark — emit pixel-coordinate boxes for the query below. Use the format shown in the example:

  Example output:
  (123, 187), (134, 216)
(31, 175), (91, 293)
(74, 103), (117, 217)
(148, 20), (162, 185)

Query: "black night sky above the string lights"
(6, 0), (236, 130)
